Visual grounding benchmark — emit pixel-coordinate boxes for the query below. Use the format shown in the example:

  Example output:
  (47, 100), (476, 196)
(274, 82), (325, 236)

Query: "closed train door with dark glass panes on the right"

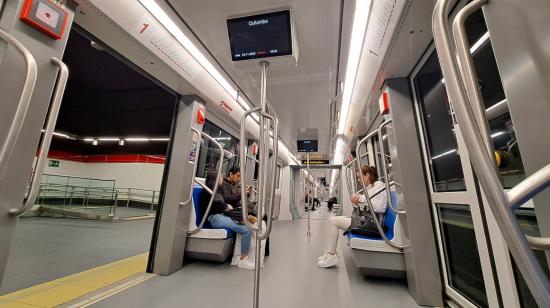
(411, 4), (550, 307)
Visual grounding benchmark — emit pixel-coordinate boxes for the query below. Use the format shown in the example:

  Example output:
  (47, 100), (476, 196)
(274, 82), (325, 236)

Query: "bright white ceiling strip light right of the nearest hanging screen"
(338, 0), (372, 134)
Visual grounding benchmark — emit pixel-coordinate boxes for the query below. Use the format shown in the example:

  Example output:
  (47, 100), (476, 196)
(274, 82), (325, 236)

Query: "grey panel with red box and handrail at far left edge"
(0, 1), (74, 286)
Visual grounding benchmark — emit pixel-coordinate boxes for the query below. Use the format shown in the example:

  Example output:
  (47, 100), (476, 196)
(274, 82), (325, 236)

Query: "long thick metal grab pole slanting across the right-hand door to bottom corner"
(432, 0), (550, 307)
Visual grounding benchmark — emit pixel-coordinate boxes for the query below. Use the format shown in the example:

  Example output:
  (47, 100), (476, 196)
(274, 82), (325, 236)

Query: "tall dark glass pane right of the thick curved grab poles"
(466, 10), (525, 188)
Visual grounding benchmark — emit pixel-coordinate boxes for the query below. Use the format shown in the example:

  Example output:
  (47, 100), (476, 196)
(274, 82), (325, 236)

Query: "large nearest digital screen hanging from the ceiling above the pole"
(227, 10), (292, 61)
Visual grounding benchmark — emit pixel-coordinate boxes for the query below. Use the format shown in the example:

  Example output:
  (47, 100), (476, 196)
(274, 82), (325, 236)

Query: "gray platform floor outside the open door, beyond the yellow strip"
(0, 217), (154, 294)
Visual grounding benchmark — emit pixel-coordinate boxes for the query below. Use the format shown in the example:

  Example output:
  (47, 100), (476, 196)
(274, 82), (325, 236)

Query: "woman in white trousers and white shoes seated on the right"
(317, 166), (388, 267)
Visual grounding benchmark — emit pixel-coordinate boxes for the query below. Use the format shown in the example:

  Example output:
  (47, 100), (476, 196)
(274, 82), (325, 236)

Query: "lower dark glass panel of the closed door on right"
(436, 203), (488, 307)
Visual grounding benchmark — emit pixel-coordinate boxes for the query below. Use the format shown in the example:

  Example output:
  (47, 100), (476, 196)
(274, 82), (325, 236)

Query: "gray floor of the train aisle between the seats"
(93, 211), (417, 308)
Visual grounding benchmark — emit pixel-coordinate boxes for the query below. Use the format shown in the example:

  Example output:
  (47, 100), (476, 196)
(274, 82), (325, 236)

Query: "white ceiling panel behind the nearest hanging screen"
(169, 0), (342, 154)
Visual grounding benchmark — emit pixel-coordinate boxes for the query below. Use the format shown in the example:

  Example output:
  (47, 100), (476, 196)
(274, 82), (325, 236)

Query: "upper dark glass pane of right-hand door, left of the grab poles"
(414, 51), (466, 192)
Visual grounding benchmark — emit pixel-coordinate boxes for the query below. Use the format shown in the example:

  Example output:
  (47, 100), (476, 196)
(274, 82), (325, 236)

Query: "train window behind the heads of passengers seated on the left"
(195, 120), (239, 177)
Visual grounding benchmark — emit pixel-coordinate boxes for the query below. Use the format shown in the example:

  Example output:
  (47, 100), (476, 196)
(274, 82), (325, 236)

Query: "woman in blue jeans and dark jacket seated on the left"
(199, 171), (254, 269)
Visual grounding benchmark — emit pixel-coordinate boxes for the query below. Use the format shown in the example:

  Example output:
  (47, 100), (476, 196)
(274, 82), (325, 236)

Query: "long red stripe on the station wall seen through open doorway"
(43, 150), (166, 164)
